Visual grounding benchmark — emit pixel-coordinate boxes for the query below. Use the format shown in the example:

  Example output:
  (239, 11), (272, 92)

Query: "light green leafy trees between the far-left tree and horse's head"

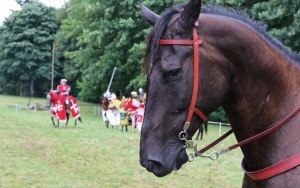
(58, 0), (183, 101)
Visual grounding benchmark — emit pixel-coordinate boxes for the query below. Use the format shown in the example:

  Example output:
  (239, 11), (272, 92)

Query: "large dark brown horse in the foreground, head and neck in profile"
(140, 0), (300, 188)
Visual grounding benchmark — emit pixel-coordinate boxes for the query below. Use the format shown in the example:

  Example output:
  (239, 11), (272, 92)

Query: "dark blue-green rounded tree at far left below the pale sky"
(0, 1), (59, 96)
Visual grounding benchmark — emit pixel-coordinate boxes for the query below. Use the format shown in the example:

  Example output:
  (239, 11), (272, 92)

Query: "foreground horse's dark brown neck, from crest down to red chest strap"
(209, 17), (300, 170)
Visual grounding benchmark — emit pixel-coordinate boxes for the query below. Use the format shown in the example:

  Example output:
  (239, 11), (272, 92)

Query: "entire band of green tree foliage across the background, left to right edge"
(0, 0), (300, 118)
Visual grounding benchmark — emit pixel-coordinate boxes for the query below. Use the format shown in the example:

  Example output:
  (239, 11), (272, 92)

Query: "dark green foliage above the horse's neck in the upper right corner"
(206, 0), (300, 52)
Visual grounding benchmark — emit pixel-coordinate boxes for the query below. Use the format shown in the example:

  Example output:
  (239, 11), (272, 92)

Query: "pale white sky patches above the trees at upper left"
(0, 0), (66, 25)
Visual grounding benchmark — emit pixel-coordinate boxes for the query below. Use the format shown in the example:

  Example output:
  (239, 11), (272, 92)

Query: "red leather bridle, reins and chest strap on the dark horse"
(159, 21), (300, 180)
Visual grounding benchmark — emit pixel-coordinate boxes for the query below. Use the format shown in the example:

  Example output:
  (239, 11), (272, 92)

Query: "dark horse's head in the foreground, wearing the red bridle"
(140, 1), (227, 176)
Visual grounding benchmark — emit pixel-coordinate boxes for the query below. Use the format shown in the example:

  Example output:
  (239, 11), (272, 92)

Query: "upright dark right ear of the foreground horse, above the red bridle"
(178, 0), (202, 30)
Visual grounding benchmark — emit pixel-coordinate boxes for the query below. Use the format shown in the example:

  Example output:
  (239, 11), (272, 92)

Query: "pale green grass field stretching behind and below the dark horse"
(0, 95), (243, 188)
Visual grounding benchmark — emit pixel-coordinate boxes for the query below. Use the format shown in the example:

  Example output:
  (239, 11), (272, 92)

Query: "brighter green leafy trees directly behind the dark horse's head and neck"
(57, 0), (300, 104)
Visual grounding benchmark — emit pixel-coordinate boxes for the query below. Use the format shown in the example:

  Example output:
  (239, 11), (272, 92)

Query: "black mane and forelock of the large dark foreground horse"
(144, 3), (300, 74)
